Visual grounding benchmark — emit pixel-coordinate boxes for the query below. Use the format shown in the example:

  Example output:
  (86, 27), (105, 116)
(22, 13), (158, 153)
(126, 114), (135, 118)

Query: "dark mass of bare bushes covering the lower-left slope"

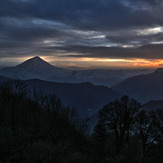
(0, 83), (91, 163)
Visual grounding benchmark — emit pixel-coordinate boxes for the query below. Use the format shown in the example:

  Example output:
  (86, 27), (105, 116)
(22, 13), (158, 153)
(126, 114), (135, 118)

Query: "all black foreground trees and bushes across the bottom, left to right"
(0, 81), (163, 163)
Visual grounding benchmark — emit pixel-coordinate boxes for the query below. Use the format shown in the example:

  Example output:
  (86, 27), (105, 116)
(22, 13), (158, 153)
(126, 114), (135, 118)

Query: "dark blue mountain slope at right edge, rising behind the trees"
(112, 68), (163, 103)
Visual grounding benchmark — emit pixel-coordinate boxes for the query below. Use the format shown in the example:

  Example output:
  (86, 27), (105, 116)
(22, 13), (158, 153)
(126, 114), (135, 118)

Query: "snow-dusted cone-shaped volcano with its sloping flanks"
(0, 56), (68, 80)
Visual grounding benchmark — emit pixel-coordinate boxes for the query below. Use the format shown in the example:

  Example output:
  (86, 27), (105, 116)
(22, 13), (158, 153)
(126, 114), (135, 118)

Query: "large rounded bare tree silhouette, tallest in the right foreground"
(95, 96), (140, 150)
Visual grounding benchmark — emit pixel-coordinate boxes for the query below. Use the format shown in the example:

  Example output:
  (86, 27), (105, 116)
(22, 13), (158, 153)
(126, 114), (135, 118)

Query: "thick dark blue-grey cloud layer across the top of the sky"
(0, 0), (163, 30)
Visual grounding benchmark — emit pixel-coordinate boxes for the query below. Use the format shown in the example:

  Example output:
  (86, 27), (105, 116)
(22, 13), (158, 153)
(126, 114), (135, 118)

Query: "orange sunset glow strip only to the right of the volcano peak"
(41, 56), (163, 68)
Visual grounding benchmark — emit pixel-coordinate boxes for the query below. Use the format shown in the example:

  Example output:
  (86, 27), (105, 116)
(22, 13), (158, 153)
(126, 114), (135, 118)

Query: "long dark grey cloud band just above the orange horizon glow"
(45, 44), (163, 59)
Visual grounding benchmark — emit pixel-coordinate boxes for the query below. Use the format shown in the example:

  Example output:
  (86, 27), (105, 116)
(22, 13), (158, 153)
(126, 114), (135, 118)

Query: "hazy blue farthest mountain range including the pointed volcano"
(0, 56), (151, 87)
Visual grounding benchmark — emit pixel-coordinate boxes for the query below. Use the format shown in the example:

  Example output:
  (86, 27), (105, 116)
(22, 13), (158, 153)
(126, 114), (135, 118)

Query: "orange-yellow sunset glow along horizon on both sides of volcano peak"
(3, 55), (163, 69)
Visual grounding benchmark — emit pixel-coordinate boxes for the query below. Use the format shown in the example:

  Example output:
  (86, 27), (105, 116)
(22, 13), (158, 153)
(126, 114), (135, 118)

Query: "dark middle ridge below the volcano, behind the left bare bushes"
(0, 76), (121, 116)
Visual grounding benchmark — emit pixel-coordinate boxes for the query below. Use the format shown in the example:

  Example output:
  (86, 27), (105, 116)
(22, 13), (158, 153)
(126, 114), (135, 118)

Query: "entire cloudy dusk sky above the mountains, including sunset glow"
(0, 0), (163, 69)
